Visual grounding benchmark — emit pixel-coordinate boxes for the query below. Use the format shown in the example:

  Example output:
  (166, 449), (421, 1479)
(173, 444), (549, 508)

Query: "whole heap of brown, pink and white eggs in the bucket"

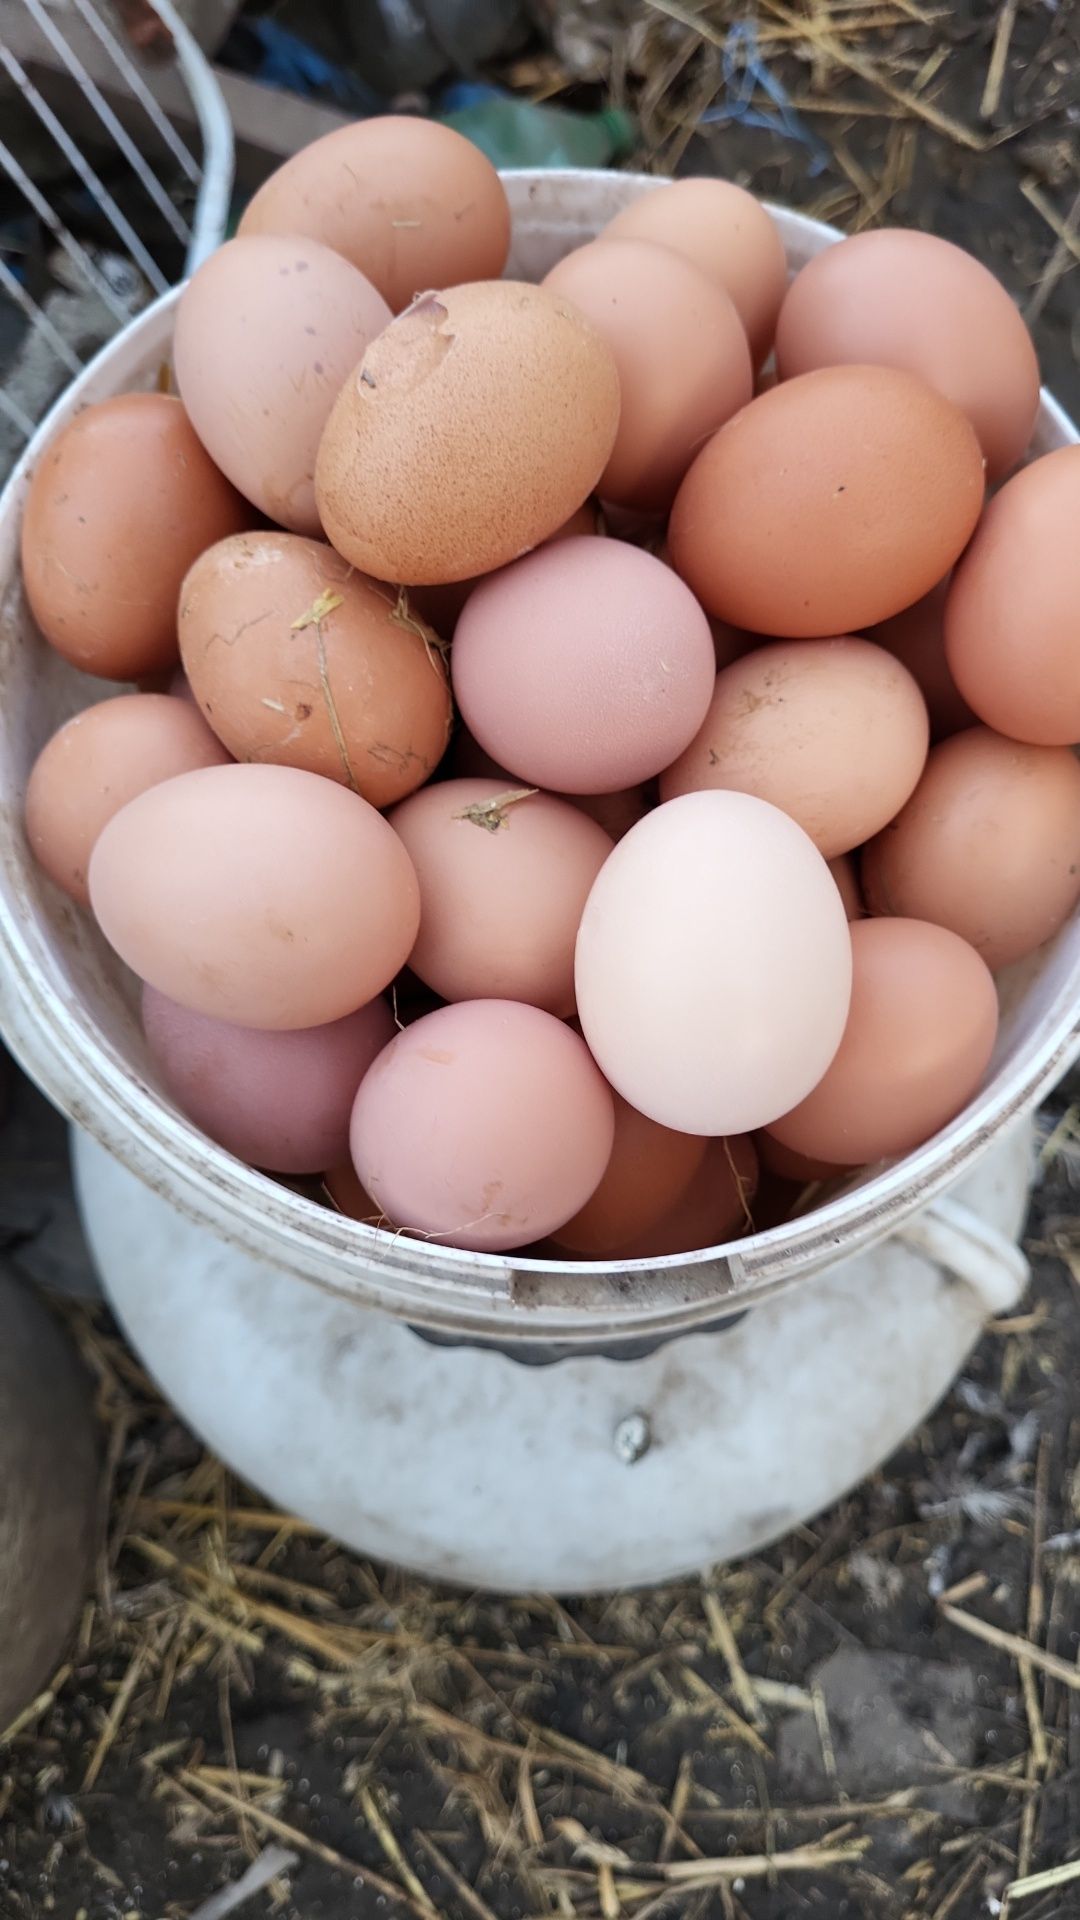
(23, 117), (1080, 1261)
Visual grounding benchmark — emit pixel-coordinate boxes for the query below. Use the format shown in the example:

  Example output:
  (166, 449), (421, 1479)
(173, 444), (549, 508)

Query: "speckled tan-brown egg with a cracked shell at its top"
(315, 280), (619, 586)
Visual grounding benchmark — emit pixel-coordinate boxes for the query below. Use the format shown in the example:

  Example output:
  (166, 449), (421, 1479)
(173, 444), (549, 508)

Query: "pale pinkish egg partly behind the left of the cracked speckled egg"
(173, 234), (390, 534)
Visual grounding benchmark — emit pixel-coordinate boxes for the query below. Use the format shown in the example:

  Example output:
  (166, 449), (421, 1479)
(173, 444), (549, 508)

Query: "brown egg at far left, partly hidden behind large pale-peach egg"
(27, 693), (229, 906)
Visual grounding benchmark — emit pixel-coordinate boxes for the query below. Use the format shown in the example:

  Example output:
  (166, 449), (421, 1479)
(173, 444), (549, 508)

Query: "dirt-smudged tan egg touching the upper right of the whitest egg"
(659, 637), (930, 858)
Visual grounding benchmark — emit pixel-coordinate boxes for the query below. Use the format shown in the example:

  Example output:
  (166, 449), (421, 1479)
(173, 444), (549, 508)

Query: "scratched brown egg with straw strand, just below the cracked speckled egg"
(179, 532), (450, 806)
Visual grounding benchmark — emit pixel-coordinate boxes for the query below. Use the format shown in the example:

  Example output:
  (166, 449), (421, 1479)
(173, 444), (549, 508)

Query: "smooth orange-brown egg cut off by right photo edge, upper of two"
(945, 445), (1080, 747)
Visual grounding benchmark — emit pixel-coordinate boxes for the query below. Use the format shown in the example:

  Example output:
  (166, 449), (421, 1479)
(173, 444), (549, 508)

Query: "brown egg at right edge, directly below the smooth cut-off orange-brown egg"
(863, 726), (1080, 972)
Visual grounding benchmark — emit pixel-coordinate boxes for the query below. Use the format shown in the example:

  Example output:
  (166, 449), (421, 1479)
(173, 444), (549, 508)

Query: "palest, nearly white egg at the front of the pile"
(577, 793), (851, 1135)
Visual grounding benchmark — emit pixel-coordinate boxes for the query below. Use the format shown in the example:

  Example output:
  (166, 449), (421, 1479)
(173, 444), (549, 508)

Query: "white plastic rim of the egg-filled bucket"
(0, 180), (1080, 1346)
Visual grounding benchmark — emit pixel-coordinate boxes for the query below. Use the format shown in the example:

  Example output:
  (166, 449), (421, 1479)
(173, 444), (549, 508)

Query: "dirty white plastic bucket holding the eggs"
(0, 171), (1080, 1590)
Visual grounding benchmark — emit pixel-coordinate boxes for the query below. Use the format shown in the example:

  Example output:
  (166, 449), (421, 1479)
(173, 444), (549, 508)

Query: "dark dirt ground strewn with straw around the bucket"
(0, 0), (1080, 1920)
